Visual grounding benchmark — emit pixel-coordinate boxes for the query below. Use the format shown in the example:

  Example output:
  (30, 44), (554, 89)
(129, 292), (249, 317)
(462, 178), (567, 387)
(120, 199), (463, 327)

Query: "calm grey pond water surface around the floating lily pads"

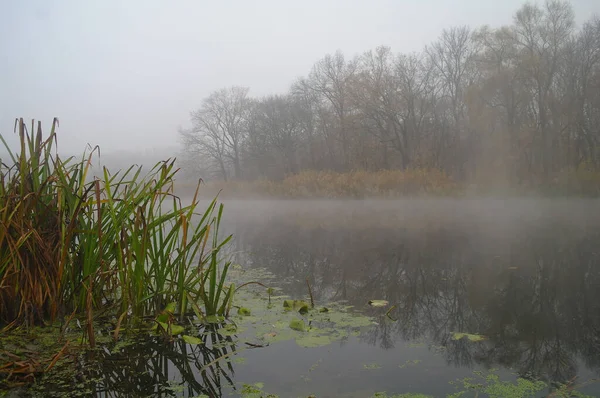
(36, 200), (600, 397)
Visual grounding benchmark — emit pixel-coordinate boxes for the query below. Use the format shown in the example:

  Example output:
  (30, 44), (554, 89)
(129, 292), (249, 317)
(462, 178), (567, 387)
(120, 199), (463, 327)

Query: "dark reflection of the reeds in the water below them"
(39, 325), (237, 397)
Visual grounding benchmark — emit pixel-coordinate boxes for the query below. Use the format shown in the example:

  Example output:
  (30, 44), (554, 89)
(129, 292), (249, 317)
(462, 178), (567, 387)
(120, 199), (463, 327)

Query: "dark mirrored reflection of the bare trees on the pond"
(230, 211), (600, 382)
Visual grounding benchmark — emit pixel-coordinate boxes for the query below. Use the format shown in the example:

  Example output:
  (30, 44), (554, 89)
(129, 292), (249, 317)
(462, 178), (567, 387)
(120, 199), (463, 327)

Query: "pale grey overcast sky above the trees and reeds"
(0, 0), (600, 153)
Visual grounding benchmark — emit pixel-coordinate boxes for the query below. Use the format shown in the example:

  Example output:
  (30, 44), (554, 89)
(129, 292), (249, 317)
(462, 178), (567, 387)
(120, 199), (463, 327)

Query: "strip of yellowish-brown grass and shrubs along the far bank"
(175, 165), (600, 199)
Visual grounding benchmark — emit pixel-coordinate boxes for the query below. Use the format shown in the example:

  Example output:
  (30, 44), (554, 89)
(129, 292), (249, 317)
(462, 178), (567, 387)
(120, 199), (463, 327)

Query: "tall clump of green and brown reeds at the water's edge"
(0, 119), (233, 332)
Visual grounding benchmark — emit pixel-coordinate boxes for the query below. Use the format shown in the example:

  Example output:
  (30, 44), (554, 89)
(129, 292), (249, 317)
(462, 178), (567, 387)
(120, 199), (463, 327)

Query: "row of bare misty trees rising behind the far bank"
(180, 0), (600, 184)
